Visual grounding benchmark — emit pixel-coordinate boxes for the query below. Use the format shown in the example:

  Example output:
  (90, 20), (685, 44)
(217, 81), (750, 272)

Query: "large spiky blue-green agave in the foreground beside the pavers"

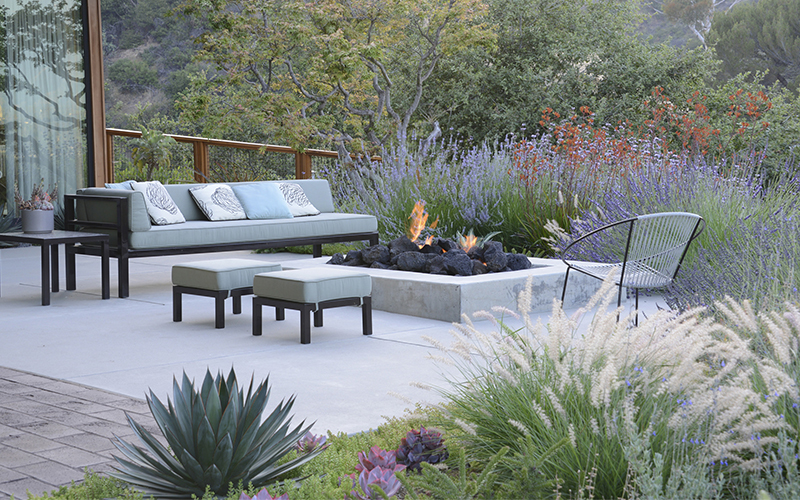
(111, 369), (324, 498)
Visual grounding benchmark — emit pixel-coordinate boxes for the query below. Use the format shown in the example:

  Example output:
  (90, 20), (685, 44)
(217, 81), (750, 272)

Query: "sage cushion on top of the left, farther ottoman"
(172, 259), (281, 290)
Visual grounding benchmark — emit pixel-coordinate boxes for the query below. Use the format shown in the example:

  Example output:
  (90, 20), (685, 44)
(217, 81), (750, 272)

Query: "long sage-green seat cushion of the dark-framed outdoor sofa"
(130, 213), (378, 249)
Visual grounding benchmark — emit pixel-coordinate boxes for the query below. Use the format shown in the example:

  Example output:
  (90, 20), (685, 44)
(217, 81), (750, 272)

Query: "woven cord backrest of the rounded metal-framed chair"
(622, 212), (705, 288)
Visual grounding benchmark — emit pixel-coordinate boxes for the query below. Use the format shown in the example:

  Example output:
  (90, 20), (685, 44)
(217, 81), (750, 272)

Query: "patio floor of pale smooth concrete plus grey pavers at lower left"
(0, 242), (664, 499)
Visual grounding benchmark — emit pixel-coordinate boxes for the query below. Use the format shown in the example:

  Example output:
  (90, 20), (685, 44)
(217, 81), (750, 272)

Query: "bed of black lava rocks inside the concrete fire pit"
(328, 236), (531, 276)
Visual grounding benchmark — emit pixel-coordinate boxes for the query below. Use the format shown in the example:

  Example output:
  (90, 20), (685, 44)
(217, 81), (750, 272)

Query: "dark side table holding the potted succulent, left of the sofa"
(0, 231), (111, 306)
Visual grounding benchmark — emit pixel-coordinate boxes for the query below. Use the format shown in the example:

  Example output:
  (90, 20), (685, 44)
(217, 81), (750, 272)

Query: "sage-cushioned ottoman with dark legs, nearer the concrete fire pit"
(253, 268), (372, 344)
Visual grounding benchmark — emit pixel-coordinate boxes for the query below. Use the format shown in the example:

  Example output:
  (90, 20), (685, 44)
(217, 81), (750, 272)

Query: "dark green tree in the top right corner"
(709, 0), (800, 90)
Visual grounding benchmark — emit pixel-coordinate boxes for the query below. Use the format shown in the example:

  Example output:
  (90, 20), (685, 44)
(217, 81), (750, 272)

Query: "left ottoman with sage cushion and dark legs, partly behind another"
(172, 259), (281, 328)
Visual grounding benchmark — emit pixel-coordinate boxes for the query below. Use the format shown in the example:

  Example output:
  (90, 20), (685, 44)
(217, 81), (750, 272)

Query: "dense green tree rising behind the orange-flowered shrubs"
(421, 0), (710, 142)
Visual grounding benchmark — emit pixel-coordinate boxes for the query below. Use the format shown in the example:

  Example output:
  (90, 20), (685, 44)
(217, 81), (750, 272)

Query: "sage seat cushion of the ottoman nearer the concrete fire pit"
(253, 268), (372, 304)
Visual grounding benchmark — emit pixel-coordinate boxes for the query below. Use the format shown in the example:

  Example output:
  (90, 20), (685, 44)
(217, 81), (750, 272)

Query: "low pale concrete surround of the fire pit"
(284, 257), (601, 322)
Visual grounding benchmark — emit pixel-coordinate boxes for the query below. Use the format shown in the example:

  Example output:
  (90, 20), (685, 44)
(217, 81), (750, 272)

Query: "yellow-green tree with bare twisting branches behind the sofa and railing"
(175, 0), (493, 152)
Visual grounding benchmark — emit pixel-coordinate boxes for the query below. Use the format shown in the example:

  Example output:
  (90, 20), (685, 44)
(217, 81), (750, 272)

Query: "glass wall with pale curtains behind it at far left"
(0, 0), (87, 210)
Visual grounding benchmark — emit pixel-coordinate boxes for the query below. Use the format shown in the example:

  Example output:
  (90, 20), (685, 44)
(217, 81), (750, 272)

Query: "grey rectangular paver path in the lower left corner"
(0, 367), (160, 500)
